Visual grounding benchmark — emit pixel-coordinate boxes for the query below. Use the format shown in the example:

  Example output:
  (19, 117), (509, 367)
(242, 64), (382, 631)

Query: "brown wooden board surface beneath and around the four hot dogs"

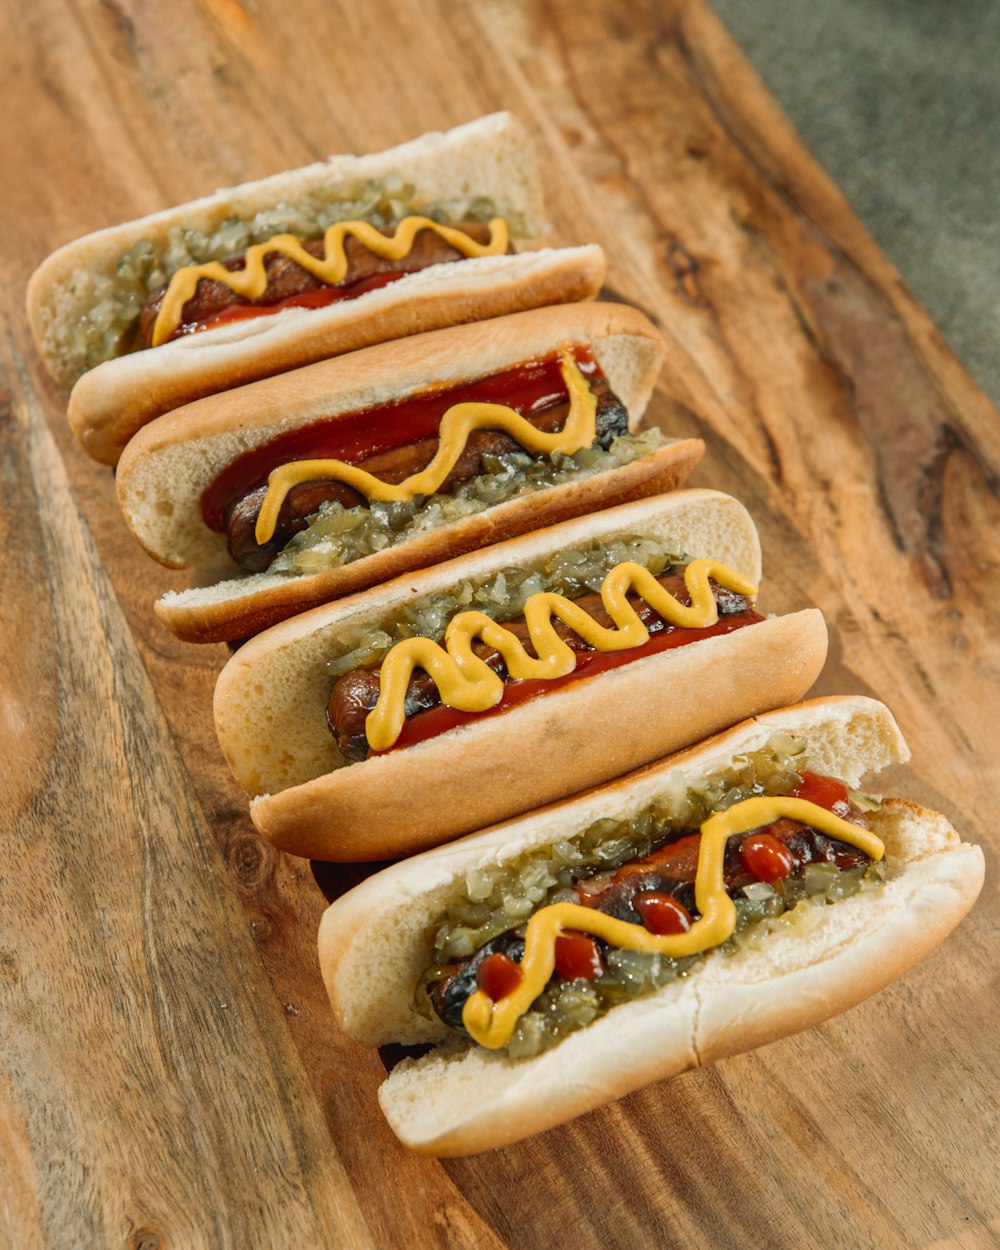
(0, 0), (1000, 1250)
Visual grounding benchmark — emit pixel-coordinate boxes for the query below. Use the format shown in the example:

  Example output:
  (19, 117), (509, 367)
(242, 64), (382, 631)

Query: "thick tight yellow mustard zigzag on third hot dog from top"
(365, 560), (756, 751)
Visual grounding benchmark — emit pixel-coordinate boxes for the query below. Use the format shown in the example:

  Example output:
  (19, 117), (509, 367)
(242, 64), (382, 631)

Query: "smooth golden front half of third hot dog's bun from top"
(250, 608), (826, 861)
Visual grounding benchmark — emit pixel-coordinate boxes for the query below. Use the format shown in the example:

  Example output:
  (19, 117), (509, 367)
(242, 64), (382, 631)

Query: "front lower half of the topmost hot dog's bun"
(68, 244), (605, 465)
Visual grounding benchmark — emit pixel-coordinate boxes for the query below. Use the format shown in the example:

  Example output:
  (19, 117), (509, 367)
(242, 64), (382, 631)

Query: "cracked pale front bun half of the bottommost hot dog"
(379, 800), (984, 1156)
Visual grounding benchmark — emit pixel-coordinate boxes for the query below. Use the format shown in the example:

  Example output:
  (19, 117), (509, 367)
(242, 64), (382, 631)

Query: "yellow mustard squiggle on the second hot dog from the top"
(254, 348), (598, 546)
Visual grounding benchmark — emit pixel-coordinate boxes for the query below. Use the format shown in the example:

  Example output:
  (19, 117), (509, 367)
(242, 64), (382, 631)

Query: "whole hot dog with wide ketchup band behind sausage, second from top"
(118, 304), (703, 641)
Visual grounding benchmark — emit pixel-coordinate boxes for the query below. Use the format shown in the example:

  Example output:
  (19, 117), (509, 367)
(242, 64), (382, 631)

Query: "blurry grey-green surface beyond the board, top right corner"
(711, 0), (1000, 408)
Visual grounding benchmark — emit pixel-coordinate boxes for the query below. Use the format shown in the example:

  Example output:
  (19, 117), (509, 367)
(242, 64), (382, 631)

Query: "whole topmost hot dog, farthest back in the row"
(28, 114), (604, 464)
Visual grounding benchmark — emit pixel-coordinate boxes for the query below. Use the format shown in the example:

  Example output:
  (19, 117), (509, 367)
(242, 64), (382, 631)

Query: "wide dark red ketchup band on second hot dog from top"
(201, 348), (601, 534)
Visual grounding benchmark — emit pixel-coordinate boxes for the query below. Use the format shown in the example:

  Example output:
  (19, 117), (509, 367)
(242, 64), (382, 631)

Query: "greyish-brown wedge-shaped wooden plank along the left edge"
(0, 349), (371, 1250)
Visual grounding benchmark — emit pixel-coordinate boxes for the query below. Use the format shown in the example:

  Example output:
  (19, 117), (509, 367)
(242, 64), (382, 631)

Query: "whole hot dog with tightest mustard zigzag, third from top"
(215, 491), (826, 860)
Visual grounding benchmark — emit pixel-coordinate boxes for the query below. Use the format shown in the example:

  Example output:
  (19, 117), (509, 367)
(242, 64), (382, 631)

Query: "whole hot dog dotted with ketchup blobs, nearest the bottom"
(319, 698), (984, 1155)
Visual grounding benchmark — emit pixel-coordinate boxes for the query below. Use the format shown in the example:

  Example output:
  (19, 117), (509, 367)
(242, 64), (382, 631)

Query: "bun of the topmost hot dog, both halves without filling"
(28, 113), (604, 464)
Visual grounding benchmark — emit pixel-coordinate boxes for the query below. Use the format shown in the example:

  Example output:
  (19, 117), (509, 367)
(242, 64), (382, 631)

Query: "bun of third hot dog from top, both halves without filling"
(215, 490), (826, 860)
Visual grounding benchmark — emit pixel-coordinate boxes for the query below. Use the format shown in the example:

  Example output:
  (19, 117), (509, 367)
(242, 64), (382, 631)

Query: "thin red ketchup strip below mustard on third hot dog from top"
(369, 610), (764, 758)
